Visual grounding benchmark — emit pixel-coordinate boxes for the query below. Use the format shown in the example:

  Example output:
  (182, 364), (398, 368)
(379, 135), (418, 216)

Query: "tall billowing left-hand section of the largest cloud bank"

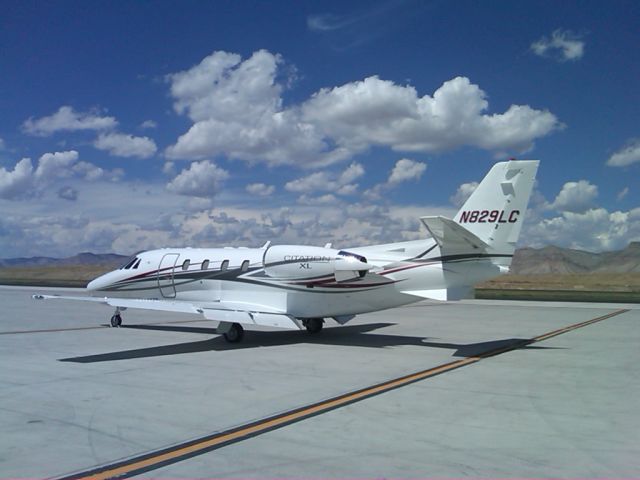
(166, 50), (347, 165)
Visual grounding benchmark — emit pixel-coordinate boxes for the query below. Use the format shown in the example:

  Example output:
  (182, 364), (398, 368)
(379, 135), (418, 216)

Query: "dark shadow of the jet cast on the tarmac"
(59, 323), (552, 363)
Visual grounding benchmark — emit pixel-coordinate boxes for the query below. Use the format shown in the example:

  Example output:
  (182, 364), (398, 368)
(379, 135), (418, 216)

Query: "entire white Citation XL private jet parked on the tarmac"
(34, 160), (539, 342)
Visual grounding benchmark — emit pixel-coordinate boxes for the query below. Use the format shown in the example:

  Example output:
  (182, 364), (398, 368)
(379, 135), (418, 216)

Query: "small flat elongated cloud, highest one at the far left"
(22, 106), (118, 137)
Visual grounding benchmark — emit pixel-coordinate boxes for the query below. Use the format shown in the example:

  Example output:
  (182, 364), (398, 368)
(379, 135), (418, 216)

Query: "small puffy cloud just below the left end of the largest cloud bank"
(167, 160), (229, 197)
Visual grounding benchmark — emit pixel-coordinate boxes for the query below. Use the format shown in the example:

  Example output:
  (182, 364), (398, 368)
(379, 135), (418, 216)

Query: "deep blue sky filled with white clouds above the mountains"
(0, 0), (640, 257)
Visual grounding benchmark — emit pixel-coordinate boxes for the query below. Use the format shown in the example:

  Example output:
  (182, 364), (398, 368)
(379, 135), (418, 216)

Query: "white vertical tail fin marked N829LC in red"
(454, 160), (540, 253)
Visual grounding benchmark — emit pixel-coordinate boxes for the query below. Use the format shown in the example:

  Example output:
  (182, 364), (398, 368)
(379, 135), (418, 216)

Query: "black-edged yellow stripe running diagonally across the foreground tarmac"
(60, 309), (629, 480)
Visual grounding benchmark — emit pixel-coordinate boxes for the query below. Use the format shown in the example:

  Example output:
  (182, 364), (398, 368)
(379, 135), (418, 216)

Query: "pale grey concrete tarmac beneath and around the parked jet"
(0, 287), (640, 478)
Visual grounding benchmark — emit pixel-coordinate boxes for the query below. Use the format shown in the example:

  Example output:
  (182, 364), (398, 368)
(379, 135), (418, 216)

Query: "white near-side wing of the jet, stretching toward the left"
(33, 295), (303, 330)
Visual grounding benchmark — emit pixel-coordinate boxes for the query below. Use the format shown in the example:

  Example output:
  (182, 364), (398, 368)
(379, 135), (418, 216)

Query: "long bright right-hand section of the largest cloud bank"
(302, 77), (562, 152)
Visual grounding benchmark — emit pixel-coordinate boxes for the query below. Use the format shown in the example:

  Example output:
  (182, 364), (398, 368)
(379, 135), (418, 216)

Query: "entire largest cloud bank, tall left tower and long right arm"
(166, 50), (562, 167)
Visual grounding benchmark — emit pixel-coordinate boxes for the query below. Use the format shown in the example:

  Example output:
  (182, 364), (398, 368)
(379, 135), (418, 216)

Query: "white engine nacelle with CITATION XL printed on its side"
(263, 245), (371, 282)
